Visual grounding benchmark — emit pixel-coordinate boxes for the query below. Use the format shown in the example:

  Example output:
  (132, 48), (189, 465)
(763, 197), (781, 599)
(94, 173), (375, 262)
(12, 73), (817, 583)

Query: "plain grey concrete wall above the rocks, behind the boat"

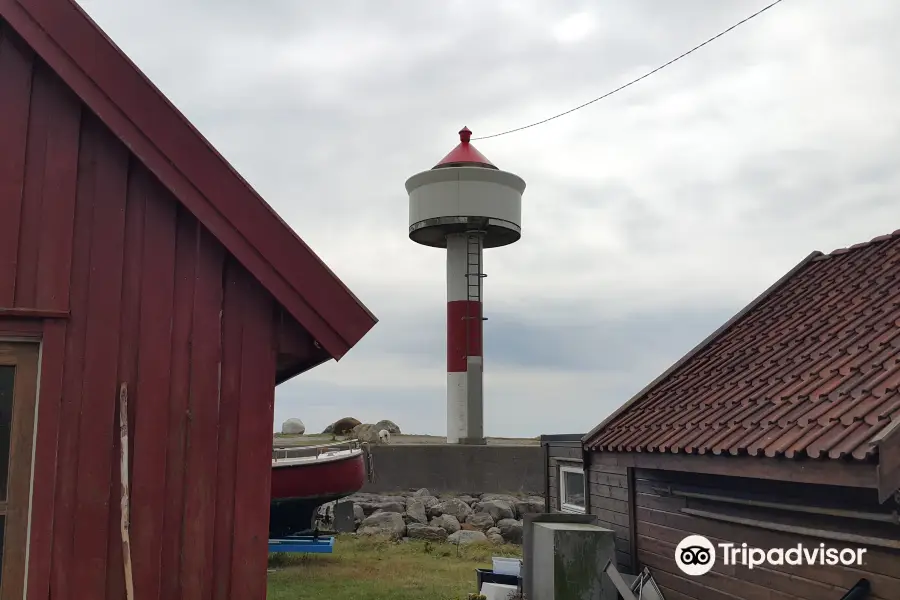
(362, 444), (545, 495)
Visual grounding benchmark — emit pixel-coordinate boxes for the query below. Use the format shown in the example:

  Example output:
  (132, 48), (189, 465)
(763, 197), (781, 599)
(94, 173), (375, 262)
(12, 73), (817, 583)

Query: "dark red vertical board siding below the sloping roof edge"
(0, 21), (276, 600)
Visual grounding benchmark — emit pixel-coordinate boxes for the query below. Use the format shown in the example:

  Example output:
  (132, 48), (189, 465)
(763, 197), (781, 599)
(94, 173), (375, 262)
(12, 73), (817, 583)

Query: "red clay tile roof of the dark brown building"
(585, 230), (900, 460)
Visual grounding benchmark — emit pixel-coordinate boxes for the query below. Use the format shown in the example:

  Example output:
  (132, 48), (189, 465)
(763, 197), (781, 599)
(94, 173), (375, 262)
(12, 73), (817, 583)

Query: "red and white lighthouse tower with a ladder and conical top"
(406, 127), (525, 444)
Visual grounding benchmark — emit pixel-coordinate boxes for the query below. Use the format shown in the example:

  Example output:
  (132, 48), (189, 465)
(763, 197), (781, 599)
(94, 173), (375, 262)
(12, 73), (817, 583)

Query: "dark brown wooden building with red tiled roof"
(584, 238), (900, 600)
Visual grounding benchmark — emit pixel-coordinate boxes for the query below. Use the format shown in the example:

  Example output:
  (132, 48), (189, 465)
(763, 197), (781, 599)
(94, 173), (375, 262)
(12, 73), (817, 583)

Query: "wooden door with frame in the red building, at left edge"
(0, 342), (38, 600)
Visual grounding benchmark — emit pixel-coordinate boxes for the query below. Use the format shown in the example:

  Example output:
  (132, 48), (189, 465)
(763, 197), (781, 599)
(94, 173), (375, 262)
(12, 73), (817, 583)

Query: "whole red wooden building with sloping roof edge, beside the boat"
(0, 0), (375, 600)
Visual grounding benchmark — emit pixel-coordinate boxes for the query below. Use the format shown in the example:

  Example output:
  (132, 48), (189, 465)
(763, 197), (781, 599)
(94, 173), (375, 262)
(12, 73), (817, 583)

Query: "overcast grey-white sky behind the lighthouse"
(81, 0), (900, 436)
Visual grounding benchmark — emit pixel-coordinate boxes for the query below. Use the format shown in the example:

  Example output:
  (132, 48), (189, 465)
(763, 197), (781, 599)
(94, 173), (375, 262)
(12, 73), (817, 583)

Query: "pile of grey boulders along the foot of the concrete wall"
(319, 488), (544, 545)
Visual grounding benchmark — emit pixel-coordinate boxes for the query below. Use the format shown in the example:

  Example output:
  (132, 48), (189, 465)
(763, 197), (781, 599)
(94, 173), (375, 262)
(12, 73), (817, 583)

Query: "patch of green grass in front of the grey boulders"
(266, 536), (522, 600)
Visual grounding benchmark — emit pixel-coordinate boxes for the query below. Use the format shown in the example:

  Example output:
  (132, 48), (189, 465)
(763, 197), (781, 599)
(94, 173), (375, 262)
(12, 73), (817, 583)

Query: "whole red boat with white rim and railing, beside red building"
(269, 440), (374, 539)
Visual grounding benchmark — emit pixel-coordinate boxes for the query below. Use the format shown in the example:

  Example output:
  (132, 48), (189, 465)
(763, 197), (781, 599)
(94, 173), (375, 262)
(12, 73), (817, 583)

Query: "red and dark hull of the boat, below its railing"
(269, 451), (366, 538)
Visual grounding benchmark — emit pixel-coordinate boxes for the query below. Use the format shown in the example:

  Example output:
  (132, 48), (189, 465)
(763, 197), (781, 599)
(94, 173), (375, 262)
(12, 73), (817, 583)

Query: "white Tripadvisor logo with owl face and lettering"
(675, 535), (866, 577)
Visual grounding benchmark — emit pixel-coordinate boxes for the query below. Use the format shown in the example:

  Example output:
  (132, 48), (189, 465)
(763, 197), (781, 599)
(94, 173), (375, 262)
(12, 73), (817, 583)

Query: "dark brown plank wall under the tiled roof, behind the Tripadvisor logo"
(635, 470), (900, 600)
